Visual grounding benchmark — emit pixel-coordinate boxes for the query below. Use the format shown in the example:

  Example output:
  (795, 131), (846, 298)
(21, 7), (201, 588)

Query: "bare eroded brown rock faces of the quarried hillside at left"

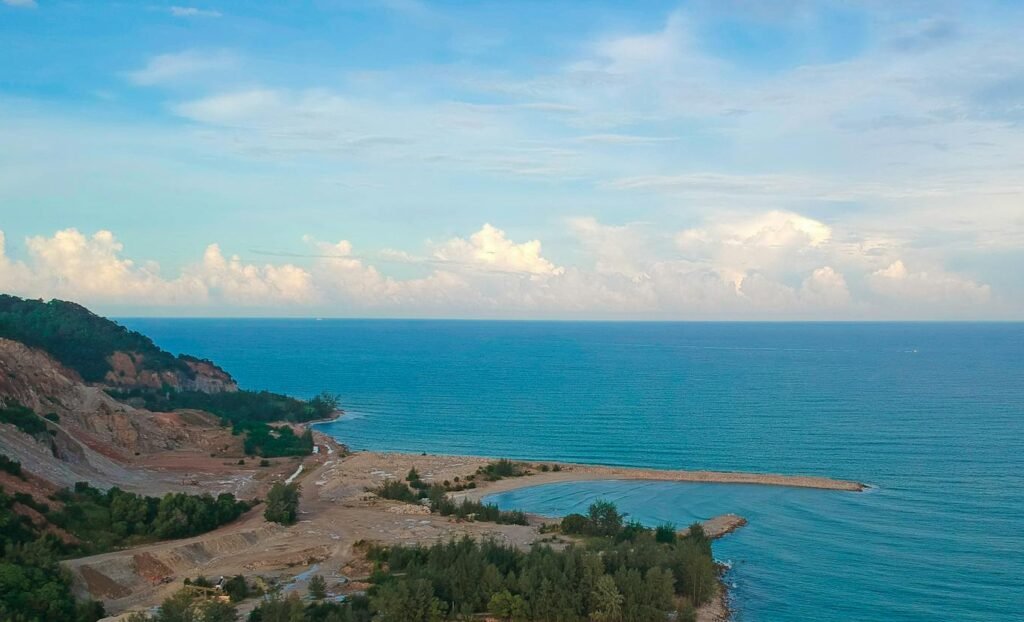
(0, 339), (243, 488)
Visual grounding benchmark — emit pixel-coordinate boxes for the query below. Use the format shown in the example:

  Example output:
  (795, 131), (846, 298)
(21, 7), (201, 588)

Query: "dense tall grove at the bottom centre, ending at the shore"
(370, 504), (718, 622)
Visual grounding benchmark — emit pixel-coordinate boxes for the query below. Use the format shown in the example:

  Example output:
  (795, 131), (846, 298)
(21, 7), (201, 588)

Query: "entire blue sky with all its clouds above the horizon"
(0, 0), (1024, 321)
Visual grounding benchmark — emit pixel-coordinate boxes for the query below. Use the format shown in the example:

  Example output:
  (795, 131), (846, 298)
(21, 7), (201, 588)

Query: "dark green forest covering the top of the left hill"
(0, 294), (195, 382)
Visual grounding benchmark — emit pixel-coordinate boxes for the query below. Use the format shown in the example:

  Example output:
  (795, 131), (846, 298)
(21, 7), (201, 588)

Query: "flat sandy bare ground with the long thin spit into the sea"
(67, 433), (861, 622)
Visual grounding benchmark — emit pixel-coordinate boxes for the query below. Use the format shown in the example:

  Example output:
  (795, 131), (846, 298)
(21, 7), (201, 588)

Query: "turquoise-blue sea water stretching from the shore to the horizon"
(123, 319), (1024, 622)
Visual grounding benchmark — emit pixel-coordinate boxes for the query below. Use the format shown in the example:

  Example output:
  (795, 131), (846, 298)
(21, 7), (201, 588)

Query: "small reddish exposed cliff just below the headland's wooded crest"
(103, 353), (239, 393)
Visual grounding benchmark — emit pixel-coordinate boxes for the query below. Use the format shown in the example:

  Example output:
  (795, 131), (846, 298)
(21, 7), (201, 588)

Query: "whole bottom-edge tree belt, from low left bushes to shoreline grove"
(112, 502), (718, 622)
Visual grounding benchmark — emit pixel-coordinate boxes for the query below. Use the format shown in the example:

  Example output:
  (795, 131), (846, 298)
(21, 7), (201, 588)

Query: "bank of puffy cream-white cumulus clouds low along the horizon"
(0, 221), (991, 319)
